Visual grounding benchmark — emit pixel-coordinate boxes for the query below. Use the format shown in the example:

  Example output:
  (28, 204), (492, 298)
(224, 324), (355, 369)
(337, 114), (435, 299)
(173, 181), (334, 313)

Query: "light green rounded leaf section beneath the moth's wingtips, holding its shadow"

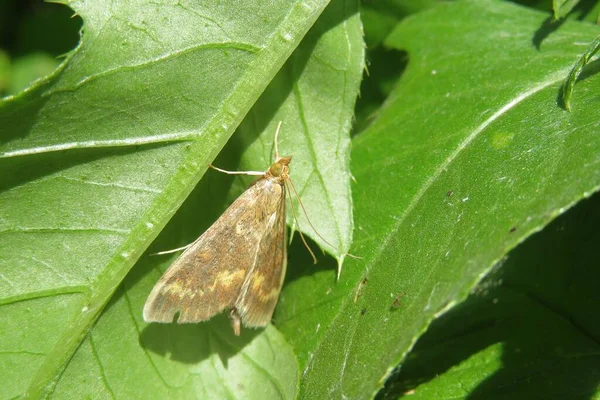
(53, 258), (298, 399)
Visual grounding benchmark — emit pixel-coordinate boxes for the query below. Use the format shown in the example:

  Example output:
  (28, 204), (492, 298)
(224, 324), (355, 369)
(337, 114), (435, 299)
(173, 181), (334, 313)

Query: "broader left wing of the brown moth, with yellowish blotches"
(144, 179), (285, 323)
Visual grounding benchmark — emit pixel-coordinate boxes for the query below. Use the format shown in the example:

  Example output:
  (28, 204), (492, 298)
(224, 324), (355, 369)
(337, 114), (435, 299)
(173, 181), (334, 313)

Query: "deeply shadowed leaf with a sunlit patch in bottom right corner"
(385, 194), (600, 399)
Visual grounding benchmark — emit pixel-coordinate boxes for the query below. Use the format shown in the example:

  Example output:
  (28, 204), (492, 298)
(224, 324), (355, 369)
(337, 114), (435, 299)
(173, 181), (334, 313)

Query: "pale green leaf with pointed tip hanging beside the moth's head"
(234, 0), (364, 269)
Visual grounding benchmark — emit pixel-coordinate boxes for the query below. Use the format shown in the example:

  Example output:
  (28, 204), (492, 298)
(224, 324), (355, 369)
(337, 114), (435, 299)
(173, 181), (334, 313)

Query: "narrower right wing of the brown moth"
(234, 185), (287, 327)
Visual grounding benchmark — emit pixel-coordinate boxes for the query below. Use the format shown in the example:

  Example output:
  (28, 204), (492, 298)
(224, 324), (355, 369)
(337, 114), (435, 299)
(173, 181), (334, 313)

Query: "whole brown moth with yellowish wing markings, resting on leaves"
(144, 122), (292, 335)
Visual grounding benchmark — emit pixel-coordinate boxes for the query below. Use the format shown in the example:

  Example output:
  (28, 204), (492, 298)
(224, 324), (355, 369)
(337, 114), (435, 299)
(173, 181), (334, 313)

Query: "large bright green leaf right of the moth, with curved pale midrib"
(277, 0), (600, 398)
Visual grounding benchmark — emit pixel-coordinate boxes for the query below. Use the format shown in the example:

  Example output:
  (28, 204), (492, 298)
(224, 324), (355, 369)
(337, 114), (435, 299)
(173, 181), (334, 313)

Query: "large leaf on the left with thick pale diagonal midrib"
(0, 1), (338, 397)
